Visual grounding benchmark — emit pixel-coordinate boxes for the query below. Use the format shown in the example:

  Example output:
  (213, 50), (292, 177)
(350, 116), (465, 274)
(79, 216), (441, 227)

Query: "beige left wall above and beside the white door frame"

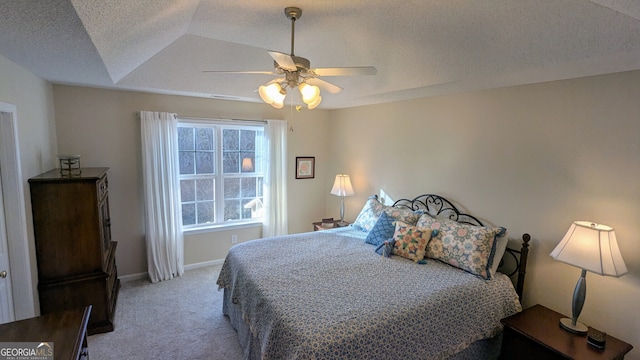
(0, 56), (56, 313)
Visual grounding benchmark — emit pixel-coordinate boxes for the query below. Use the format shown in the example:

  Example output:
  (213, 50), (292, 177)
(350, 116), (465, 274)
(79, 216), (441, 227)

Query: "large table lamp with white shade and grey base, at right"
(551, 221), (627, 334)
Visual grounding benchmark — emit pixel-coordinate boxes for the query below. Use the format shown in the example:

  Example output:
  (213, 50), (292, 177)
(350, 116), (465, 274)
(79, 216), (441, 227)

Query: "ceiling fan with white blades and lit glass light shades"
(205, 7), (377, 109)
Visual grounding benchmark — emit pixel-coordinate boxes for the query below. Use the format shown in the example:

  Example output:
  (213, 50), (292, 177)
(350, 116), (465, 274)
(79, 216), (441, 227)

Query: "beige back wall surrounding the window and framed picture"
(53, 85), (330, 275)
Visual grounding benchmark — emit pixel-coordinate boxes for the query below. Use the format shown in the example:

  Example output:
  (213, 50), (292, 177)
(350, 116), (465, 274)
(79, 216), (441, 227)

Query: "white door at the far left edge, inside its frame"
(0, 169), (15, 324)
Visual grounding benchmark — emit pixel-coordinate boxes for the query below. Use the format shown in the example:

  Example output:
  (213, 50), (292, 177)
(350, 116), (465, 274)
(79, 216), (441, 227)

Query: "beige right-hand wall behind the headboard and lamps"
(327, 71), (640, 359)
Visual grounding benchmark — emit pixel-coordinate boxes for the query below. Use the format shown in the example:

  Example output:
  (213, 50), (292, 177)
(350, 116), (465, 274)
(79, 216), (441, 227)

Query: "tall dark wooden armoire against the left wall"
(29, 168), (120, 335)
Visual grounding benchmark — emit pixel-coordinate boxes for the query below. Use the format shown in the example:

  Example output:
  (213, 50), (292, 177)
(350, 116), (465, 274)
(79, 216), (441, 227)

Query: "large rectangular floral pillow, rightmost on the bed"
(416, 216), (506, 279)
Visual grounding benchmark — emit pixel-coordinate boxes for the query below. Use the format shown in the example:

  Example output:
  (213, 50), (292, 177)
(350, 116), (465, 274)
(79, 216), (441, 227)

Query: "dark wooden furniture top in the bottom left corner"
(0, 305), (91, 360)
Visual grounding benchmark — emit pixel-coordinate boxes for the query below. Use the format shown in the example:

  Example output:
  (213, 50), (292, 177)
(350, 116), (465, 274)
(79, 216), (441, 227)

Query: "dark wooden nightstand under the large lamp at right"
(500, 305), (633, 360)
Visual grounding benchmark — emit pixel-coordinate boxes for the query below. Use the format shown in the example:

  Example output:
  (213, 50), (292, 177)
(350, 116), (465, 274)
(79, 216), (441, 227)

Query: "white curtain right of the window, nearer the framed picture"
(262, 120), (289, 237)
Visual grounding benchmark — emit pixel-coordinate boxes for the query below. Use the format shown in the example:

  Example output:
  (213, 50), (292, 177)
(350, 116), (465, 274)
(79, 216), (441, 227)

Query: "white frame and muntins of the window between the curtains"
(178, 118), (269, 233)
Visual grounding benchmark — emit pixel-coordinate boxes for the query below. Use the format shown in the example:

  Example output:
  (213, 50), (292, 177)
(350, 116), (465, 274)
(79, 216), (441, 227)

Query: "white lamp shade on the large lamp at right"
(551, 221), (627, 277)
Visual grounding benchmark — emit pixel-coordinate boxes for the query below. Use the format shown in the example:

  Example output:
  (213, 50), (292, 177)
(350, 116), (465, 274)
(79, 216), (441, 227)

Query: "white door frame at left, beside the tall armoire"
(0, 102), (35, 320)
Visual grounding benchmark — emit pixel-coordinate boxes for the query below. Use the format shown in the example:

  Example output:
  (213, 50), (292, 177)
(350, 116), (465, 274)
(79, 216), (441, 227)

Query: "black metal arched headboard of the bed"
(393, 194), (531, 302)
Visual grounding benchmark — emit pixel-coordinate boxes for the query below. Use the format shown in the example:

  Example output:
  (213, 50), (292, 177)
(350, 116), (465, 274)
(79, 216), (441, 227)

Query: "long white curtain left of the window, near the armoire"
(140, 111), (184, 282)
